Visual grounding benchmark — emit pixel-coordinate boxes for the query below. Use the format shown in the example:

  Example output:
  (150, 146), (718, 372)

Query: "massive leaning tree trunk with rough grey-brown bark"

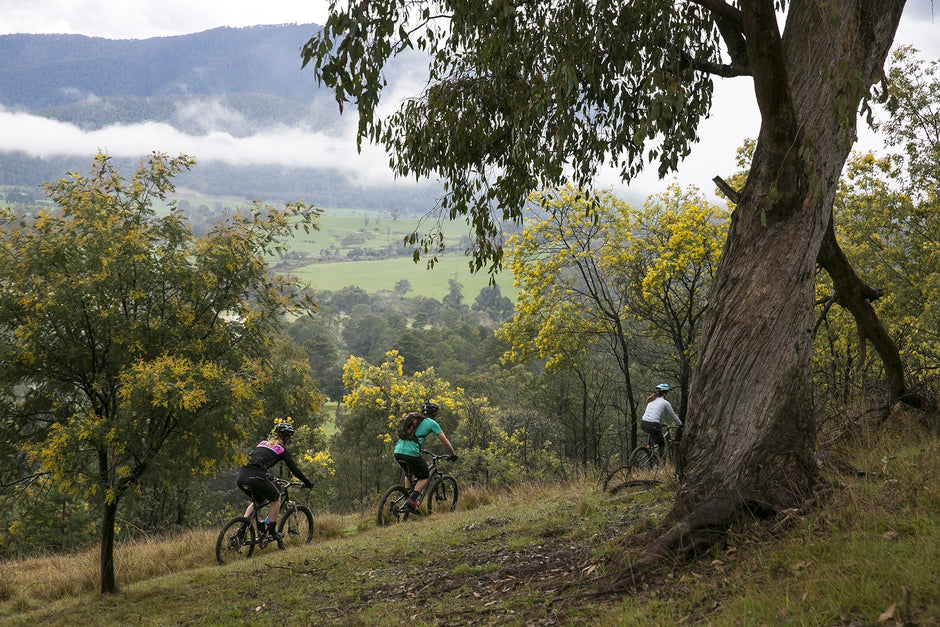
(672, 0), (904, 520)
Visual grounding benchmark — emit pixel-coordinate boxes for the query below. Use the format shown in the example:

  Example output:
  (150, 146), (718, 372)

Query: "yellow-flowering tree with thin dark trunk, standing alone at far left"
(0, 153), (321, 592)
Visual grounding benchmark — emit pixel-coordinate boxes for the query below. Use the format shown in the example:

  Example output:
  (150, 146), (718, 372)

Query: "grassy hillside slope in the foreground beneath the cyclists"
(0, 429), (940, 626)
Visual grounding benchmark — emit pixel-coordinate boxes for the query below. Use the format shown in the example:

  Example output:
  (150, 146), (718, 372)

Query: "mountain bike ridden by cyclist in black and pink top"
(215, 477), (313, 565)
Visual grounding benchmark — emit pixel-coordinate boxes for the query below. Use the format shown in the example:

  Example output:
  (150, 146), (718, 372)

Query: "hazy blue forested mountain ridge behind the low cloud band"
(0, 24), (442, 213)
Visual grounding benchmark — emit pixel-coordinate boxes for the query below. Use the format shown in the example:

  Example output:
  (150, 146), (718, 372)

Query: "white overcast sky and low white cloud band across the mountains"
(0, 0), (940, 195)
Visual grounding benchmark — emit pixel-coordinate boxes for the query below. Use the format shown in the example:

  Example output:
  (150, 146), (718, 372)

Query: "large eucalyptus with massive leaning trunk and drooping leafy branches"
(302, 0), (905, 568)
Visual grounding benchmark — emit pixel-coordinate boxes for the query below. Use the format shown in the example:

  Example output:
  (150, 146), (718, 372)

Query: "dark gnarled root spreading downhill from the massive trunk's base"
(611, 490), (777, 592)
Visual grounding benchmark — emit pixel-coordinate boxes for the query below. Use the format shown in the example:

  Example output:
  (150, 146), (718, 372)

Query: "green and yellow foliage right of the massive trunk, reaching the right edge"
(815, 47), (940, 418)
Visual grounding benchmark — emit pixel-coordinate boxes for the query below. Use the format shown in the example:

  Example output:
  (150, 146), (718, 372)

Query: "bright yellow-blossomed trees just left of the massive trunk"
(498, 187), (728, 459)
